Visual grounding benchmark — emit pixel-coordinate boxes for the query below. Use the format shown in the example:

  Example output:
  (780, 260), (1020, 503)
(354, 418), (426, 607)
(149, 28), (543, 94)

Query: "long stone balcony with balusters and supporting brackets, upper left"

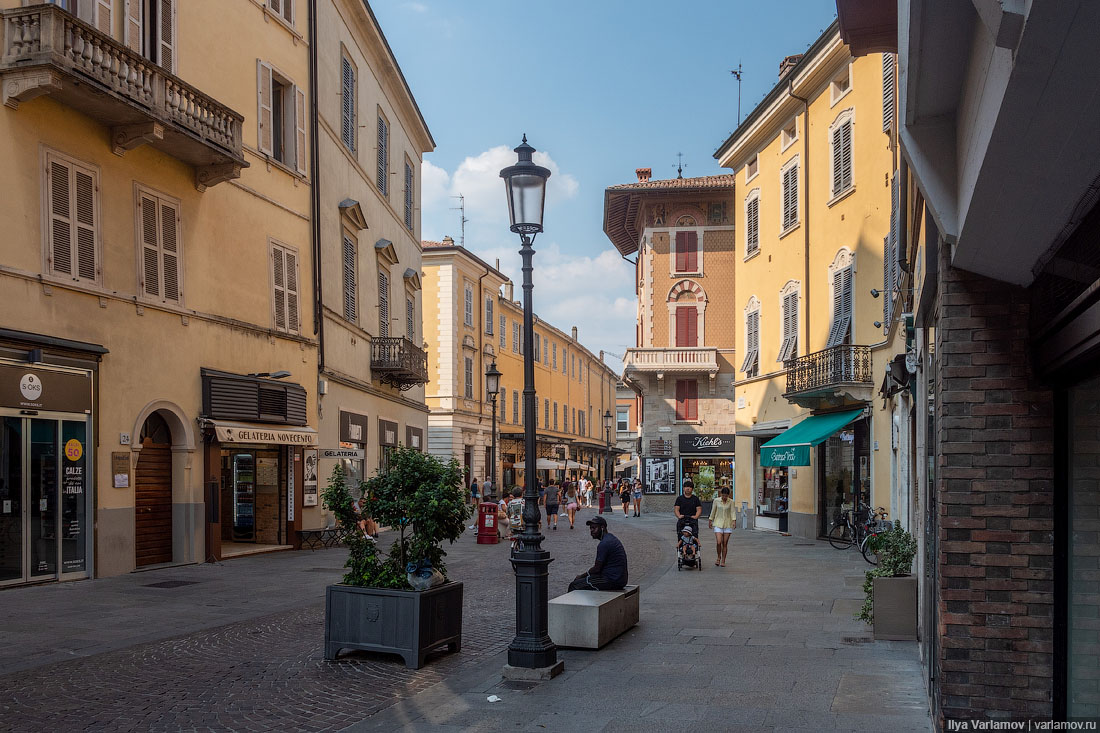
(0, 4), (249, 190)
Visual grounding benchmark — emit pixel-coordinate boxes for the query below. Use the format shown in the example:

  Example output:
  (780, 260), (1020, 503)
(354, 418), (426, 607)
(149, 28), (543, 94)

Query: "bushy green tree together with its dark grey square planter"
(322, 448), (470, 669)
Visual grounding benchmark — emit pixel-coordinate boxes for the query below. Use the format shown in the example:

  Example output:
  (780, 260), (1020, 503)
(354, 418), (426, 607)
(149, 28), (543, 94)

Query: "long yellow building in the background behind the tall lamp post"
(424, 238), (617, 495)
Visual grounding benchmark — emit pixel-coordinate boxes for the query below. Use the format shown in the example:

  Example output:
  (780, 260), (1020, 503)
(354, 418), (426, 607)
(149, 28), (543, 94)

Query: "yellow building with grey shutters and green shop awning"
(715, 24), (903, 537)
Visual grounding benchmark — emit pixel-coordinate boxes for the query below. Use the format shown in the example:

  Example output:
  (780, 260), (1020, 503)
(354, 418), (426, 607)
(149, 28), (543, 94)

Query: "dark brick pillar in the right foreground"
(935, 248), (1054, 727)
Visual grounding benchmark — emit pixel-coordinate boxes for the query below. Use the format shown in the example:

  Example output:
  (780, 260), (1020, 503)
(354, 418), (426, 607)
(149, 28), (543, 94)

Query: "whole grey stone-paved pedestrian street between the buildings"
(0, 510), (931, 731)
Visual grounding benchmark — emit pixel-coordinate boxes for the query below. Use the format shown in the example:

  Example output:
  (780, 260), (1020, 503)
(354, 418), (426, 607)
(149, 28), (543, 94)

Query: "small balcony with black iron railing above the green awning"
(783, 343), (875, 409)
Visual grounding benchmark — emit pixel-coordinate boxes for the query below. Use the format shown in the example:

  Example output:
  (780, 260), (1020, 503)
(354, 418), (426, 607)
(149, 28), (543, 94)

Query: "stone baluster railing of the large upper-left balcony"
(0, 4), (244, 160)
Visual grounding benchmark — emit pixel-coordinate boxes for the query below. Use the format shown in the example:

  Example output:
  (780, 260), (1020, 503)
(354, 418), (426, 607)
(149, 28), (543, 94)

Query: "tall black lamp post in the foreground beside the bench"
(501, 135), (564, 679)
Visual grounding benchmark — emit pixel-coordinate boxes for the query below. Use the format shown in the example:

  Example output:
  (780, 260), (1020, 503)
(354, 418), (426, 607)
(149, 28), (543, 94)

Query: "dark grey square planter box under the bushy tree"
(325, 582), (462, 669)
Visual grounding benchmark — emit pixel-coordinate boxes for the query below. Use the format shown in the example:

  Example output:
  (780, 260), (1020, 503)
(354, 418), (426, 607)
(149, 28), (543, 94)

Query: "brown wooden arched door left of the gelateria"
(134, 413), (172, 568)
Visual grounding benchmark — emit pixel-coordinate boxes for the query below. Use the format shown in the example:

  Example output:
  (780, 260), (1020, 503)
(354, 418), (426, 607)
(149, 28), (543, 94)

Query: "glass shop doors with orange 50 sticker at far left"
(0, 416), (88, 584)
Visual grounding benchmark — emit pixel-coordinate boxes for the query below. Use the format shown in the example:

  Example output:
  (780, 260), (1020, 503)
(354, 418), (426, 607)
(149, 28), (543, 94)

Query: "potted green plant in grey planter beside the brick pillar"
(858, 519), (916, 641)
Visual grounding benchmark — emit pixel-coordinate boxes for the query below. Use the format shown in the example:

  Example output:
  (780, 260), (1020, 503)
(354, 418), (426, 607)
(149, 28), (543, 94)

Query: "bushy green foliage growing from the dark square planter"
(322, 448), (470, 590)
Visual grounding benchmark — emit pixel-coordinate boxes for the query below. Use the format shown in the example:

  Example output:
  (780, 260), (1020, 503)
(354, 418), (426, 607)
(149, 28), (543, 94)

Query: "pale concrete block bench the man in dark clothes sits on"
(548, 586), (641, 649)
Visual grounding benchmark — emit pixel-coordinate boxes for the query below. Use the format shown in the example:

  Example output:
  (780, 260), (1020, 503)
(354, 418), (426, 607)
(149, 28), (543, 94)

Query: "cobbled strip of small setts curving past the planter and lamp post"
(0, 510), (667, 733)
